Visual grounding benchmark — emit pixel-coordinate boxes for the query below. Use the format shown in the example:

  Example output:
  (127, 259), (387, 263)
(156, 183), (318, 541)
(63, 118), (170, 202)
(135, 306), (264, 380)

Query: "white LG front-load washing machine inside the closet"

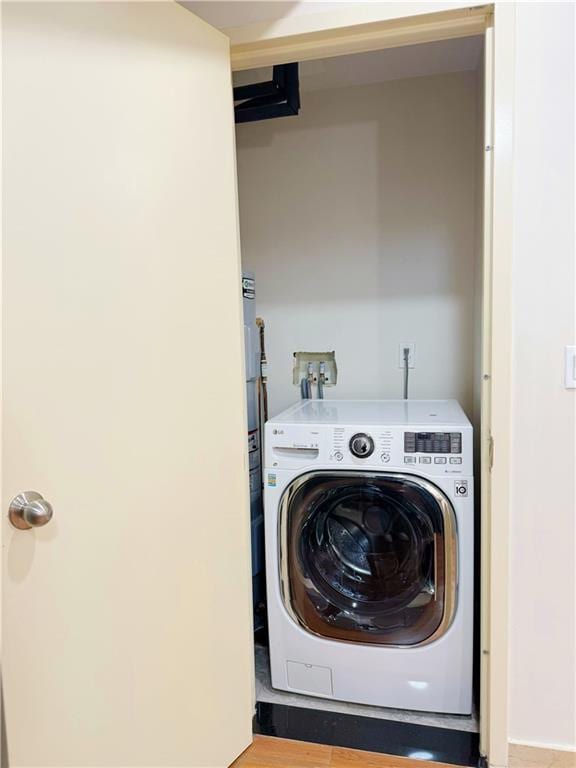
(264, 400), (474, 714)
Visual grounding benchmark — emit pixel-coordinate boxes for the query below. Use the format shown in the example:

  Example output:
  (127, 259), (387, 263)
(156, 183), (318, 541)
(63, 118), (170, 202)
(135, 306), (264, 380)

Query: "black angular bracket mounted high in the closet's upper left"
(234, 63), (300, 123)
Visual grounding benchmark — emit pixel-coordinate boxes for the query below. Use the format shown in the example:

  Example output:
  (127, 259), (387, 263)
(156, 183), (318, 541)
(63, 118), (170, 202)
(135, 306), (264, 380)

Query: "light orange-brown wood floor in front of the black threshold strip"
(230, 736), (462, 768)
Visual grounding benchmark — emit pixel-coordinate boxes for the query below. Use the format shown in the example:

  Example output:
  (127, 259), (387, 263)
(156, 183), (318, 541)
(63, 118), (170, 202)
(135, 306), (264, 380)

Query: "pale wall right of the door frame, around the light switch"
(508, 3), (576, 748)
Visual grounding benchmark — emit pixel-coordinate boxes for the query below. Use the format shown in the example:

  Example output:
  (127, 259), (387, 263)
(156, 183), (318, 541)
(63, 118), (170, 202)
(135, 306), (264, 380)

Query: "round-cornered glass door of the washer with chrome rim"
(279, 472), (457, 646)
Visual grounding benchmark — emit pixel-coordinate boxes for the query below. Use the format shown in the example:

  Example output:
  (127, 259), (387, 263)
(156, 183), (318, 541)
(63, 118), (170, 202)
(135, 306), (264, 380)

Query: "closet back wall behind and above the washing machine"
(237, 72), (481, 416)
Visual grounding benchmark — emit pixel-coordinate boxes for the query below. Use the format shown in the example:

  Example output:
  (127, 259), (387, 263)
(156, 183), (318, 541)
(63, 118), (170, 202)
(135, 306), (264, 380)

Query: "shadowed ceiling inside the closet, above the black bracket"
(234, 37), (483, 92)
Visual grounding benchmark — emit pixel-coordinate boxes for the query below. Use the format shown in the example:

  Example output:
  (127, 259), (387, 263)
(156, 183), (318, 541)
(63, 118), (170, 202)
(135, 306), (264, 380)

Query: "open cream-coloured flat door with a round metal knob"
(2, 2), (252, 768)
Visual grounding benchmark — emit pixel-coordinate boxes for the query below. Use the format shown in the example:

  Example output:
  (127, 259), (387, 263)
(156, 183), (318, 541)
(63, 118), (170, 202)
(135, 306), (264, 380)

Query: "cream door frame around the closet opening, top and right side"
(231, 2), (515, 768)
